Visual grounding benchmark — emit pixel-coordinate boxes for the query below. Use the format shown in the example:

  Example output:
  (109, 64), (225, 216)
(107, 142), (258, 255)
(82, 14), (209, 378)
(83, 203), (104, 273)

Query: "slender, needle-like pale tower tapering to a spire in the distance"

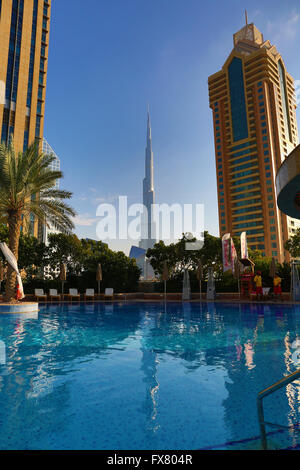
(129, 109), (156, 279)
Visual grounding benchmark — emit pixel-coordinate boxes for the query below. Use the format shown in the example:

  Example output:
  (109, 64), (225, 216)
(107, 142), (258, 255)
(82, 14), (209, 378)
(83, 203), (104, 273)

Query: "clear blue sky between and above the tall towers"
(44, 0), (300, 252)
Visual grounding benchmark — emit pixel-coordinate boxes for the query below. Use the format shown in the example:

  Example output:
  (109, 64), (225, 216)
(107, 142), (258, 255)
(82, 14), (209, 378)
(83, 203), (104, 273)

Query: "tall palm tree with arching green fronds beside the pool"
(0, 142), (75, 302)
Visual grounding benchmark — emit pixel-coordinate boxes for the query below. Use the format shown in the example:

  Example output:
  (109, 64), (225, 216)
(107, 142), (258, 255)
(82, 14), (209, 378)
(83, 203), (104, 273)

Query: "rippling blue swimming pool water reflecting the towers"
(0, 303), (300, 450)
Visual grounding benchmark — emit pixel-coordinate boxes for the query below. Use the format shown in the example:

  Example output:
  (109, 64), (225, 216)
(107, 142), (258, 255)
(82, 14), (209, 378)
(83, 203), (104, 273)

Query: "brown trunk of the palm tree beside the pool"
(5, 211), (21, 302)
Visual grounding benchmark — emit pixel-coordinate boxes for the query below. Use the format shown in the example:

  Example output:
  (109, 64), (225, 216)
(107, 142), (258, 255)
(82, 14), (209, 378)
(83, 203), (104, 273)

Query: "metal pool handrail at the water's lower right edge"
(257, 369), (300, 450)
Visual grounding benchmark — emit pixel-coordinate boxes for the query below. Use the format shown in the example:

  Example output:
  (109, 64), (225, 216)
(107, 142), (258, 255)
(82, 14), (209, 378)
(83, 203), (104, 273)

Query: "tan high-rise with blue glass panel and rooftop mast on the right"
(208, 18), (298, 262)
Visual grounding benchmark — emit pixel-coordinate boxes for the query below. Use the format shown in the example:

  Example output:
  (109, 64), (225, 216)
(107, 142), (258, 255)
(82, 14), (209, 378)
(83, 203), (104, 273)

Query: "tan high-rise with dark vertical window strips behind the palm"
(0, 0), (51, 151)
